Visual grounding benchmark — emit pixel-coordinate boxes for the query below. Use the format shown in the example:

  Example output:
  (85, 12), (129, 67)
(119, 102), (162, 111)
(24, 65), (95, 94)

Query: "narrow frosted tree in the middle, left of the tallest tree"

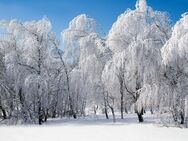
(62, 14), (110, 117)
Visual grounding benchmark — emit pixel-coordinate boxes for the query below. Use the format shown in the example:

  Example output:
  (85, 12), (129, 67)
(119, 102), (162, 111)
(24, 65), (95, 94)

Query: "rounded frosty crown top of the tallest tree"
(107, 0), (170, 52)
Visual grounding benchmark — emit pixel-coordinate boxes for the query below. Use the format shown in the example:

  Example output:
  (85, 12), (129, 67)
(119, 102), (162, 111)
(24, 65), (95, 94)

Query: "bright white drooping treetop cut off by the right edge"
(162, 14), (188, 66)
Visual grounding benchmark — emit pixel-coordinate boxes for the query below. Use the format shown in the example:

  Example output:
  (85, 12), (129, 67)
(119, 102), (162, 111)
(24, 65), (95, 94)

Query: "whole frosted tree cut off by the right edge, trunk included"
(162, 14), (188, 124)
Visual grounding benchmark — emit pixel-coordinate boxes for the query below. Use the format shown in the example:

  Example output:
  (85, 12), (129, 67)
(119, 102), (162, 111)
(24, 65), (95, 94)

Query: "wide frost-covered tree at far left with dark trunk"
(1, 18), (64, 124)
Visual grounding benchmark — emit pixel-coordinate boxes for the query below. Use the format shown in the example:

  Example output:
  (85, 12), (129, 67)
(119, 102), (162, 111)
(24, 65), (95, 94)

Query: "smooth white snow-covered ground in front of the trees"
(0, 115), (188, 141)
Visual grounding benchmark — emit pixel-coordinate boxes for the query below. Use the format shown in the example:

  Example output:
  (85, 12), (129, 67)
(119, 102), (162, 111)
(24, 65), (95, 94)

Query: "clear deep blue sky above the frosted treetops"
(0, 0), (188, 35)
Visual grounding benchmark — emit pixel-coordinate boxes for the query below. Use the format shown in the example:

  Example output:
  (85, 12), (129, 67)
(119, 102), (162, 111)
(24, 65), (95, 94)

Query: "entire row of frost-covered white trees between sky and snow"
(0, 0), (188, 126)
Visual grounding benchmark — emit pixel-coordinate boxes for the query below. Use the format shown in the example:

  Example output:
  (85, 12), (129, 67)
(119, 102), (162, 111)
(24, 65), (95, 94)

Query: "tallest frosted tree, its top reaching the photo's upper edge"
(107, 0), (170, 121)
